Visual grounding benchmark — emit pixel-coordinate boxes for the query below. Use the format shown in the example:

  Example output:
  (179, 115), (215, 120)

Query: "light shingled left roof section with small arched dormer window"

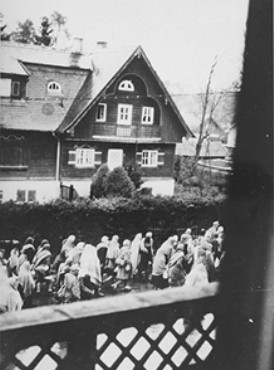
(0, 42), (91, 132)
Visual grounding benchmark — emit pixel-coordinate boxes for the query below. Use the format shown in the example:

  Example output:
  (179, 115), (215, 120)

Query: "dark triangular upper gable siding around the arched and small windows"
(74, 57), (186, 143)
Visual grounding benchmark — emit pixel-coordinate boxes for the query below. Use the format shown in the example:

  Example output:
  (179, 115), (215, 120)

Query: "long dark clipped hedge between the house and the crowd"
(0, 196), (225, 254)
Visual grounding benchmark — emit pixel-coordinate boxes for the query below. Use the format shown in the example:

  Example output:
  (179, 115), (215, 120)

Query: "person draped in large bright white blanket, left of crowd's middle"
(78, 244), (103, 299)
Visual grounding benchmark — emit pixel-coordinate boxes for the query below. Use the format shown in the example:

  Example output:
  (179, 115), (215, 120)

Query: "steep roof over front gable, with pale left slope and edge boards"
(57, 46), (193, 136)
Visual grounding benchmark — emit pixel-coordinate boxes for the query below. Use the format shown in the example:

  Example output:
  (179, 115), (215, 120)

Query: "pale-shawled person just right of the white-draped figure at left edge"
(18, 250), (35, 308)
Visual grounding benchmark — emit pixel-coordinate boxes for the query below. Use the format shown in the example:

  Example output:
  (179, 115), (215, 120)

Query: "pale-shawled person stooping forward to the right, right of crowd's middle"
(151, 235), (178, 289)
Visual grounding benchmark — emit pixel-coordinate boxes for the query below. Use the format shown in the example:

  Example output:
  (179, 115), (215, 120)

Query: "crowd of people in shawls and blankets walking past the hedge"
(0, 221), (225, 313)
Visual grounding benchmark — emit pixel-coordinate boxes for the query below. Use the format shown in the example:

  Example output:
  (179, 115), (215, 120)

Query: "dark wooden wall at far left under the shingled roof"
(0, 131), (56, 180)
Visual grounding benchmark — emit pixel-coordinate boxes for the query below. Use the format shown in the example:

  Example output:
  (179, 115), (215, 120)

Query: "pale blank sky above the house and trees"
(0, 0), (248, 94)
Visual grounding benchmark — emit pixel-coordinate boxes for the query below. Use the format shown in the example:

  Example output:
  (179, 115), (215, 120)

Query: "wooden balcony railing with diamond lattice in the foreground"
(0, 283), (218, 370)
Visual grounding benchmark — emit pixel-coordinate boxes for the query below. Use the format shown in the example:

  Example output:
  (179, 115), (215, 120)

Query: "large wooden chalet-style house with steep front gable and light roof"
(0, 40), (193, 202)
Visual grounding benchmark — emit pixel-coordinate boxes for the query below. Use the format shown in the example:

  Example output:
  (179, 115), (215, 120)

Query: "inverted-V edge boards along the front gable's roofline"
(57, 45), (195, 137)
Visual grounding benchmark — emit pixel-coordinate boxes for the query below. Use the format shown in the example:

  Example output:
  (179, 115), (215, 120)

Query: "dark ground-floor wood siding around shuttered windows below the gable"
(60, 141), (175, 181)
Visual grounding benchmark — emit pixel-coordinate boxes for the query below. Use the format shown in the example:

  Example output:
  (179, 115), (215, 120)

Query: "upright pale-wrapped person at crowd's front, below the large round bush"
(112, 239), (132, 292)
